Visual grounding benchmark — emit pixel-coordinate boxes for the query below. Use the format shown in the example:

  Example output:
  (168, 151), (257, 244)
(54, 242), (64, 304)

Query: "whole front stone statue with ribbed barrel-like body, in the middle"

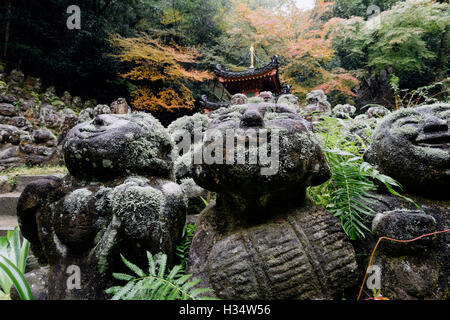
(188, 103), (357, 299)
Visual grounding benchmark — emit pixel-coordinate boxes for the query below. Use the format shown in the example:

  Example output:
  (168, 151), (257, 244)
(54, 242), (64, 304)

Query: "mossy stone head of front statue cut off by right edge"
(365, 103), (450, 198)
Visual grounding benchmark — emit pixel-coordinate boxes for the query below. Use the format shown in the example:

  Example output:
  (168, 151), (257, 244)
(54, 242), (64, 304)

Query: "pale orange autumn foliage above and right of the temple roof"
(227, 0), (358, 98)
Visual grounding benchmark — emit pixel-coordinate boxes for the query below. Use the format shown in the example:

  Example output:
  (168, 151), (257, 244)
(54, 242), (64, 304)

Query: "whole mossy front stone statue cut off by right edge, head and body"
(366, 103), (450, 299)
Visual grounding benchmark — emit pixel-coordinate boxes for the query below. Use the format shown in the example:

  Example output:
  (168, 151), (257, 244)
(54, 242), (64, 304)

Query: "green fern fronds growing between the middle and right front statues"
(308, 118), (412, 240)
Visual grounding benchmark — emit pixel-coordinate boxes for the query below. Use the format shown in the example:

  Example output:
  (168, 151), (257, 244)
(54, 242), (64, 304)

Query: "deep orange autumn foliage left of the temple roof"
(111, 34), (213, 113)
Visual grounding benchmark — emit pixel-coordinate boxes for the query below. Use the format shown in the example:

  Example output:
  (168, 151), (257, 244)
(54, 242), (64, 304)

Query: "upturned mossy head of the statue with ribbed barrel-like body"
(193, 104), (330, 195)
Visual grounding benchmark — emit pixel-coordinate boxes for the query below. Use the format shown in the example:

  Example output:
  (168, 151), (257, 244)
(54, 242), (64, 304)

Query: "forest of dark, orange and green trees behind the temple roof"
(0, 0), (450, 119)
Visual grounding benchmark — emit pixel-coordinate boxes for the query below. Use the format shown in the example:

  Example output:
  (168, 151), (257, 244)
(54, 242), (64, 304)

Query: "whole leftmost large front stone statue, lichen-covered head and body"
(18, 113), (186, 299)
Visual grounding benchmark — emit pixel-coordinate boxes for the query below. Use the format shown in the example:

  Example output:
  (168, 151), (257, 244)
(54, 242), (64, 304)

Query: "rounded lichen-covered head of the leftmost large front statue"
(63, 113), (174, 180)
